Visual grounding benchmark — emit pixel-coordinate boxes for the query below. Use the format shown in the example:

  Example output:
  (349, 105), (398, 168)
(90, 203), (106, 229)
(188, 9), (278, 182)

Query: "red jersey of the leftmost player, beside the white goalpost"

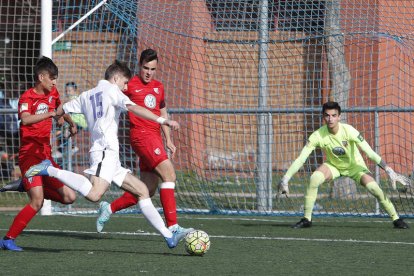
(18, 88), (60, 159)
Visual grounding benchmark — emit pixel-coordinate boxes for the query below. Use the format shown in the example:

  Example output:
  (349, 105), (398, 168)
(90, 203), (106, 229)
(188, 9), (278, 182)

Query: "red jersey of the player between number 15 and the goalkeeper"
(124, 76), (165, 135)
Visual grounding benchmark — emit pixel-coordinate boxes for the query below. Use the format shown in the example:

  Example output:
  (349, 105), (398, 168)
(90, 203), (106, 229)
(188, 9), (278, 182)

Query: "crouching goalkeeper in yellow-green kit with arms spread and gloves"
(279, 102), (409, 229)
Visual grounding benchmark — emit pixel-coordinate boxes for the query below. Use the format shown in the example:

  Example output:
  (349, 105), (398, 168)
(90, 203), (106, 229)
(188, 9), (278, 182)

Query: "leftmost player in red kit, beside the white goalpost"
(0, 57), (76, 251)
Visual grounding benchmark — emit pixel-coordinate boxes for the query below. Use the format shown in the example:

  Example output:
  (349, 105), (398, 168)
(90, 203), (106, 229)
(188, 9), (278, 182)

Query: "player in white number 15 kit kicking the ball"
(26, 61), (184, 248)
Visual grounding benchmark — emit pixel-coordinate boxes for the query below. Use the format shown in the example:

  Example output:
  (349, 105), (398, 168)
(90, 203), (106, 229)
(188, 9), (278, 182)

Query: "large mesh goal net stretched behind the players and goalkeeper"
(0, 0), (414, 219)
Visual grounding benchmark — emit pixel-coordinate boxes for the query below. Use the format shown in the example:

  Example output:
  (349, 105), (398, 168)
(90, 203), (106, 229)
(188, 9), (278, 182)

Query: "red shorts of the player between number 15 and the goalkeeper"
(131, 134), (168, 172)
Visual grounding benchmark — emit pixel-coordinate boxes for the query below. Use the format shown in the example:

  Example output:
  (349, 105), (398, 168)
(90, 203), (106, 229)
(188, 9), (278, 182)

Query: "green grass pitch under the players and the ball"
(0, 212), (414, 276)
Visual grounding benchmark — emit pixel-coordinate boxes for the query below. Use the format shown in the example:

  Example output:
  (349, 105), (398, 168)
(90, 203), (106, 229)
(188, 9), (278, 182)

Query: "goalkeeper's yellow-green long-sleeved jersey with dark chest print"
(285, 123), (381, 178)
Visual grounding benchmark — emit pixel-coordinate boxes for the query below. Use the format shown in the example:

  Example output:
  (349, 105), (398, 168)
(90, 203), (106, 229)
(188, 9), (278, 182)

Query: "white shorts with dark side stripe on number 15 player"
(84, 150), (131, 187)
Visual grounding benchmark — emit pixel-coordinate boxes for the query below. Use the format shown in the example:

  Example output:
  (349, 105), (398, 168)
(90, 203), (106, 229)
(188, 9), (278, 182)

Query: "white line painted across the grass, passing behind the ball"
(0, 229), (414, 245)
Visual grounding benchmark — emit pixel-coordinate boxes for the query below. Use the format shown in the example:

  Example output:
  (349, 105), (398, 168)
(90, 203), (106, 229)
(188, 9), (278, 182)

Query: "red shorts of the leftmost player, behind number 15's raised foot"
(19, 155), (64, 191)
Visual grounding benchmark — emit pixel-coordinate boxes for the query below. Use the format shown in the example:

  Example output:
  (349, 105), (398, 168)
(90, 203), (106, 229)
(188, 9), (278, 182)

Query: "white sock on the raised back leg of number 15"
(47, 166), (92, 196)
